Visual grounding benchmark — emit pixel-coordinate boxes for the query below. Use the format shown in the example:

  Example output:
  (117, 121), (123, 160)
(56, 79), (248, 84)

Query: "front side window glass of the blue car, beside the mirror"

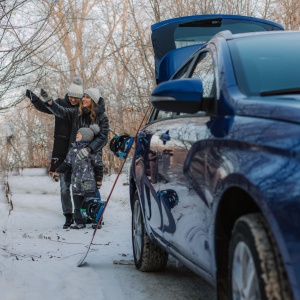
(191, 52), (215, 98)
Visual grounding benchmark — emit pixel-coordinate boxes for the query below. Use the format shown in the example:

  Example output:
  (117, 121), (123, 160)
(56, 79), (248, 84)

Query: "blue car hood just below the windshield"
(235, 95), (300, 124)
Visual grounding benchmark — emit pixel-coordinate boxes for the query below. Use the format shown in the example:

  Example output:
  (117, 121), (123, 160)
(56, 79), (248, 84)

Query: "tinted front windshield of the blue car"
(228, 32), (300, 96)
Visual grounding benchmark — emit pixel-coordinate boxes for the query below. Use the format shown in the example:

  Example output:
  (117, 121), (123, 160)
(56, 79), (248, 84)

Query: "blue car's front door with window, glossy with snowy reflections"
(158, 51), (218, 272)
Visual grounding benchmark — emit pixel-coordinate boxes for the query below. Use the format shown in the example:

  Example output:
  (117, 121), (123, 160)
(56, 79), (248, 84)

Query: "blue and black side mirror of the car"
(151, 78), (203, 113)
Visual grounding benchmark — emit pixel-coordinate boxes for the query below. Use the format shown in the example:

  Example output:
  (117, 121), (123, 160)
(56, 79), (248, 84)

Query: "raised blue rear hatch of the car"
(151, 15), (284, 84)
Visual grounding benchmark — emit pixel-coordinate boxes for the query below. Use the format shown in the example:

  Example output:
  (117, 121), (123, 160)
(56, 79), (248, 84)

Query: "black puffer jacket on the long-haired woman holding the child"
(47, 101), (109, 153)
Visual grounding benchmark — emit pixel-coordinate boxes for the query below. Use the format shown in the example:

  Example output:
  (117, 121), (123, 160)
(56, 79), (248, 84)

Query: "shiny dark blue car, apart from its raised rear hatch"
(130, 15), (300, 300)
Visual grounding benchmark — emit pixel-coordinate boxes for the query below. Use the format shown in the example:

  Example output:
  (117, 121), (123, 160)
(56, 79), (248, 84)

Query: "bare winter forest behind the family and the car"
(0, 0), (300, 173)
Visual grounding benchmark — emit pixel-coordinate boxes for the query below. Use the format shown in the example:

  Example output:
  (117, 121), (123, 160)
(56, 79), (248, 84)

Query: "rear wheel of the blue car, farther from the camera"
(131, 192), (168, 272)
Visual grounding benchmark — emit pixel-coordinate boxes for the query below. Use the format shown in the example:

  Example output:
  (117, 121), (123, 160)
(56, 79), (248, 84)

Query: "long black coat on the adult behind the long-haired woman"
(26, 90), (78, 172)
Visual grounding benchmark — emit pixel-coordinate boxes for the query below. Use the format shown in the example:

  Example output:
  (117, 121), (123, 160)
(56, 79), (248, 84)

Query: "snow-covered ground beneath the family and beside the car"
(0, 169), (214, 300)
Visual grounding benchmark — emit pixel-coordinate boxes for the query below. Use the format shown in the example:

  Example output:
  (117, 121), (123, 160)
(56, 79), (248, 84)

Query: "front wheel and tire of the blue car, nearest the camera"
(229, 214), (293, 300)
